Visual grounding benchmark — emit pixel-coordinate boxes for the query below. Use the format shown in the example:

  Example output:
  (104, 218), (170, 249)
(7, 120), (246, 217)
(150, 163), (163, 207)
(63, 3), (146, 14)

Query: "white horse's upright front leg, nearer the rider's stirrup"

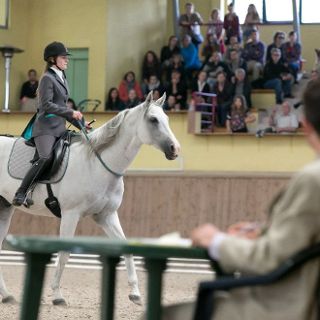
(51, 212), (79, 305)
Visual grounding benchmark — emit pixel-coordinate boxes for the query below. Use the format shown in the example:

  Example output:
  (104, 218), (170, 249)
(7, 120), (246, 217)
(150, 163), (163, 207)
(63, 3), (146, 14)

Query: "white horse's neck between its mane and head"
(101, 108), (142, 173)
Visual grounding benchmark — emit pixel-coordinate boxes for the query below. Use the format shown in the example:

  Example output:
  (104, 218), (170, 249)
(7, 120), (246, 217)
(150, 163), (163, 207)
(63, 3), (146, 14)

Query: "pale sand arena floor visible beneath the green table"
(0, 266), (212, 320)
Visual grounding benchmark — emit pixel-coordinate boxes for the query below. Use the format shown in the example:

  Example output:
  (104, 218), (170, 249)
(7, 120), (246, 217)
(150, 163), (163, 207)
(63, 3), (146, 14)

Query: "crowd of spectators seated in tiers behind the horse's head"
(105, 3), (308, 132)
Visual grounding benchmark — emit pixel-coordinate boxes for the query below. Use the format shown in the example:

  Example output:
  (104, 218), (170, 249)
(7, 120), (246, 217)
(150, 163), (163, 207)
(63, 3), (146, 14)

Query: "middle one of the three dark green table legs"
(101, 256), (120, 320)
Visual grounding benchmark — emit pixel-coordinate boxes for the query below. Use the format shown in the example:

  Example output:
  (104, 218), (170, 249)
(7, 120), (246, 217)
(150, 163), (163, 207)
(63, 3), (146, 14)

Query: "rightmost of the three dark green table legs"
(145, 258), (167, 320)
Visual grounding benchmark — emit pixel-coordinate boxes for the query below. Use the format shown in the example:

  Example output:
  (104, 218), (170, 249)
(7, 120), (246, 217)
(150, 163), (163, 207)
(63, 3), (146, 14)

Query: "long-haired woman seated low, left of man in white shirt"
(227, 95), (256, 133)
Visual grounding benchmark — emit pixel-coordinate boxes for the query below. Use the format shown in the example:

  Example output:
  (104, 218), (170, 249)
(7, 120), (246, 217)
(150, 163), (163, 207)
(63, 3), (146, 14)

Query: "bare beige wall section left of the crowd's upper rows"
(106, 0), (171, 93)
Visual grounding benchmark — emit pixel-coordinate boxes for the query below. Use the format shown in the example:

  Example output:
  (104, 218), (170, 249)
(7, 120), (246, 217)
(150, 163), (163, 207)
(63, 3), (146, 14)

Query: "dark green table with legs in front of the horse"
(6, 235), (208, 320)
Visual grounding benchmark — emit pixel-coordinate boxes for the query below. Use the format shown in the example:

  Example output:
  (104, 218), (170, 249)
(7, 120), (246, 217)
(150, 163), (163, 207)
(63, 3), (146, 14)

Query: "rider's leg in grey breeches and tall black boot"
(12, 135), (57, 206)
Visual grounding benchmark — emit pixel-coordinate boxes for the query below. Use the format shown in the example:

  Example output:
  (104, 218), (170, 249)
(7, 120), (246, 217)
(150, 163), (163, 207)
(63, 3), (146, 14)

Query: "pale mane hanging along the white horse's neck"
(89, 109), (129, 152)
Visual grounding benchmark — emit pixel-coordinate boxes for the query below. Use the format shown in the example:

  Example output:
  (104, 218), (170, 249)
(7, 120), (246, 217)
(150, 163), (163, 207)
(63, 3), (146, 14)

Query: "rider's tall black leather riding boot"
(12, 159), (49, 206)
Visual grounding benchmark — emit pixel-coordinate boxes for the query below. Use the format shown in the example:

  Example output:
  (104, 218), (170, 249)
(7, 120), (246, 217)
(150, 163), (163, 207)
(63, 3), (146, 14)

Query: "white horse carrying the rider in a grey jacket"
(0, 93), (180, 304)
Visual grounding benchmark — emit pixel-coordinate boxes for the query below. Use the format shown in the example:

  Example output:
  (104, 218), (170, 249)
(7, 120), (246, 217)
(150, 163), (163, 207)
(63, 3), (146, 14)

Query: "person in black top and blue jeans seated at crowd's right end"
(263, 48), (292, 104)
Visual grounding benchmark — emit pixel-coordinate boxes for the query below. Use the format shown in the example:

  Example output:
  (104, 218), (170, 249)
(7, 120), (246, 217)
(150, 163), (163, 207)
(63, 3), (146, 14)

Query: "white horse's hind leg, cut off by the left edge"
(0, 196), (16, 303)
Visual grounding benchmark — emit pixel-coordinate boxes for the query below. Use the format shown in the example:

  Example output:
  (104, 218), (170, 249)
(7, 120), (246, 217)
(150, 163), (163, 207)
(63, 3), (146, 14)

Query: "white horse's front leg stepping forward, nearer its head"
(93, 212), (141, 305)
